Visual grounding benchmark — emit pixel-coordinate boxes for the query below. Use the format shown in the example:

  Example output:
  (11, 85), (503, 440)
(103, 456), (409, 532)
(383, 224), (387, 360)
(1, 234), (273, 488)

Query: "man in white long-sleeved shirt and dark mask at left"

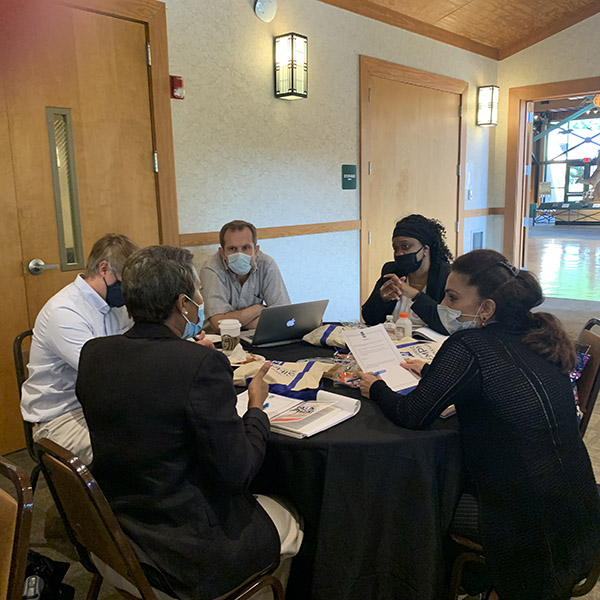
(21, 233), (139, 464)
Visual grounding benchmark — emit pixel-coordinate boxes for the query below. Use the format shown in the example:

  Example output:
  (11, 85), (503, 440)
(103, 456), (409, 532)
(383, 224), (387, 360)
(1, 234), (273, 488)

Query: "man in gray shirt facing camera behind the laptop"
(200, 221), (290, 331)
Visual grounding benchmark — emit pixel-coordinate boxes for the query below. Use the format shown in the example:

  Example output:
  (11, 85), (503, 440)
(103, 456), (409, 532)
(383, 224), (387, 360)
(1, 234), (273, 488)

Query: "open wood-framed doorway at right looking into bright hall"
(504, 77), (600, 308)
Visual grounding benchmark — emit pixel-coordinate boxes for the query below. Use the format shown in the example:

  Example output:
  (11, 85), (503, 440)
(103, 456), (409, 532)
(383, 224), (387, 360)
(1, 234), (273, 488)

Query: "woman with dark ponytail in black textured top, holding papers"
(361, 250), (600, 600)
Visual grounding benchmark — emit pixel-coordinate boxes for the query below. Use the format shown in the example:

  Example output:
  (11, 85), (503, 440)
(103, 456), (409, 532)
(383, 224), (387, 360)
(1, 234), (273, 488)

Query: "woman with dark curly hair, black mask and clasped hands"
(362, 215), (452, 334)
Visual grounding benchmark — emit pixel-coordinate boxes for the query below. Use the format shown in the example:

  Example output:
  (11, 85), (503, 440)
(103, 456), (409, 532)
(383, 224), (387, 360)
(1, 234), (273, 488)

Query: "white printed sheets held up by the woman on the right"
(343, 323), (419, 392)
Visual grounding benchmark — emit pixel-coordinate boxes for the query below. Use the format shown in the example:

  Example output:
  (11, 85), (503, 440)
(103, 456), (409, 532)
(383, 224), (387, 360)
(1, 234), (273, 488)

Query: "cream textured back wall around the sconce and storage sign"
(167, 0), (501, 320)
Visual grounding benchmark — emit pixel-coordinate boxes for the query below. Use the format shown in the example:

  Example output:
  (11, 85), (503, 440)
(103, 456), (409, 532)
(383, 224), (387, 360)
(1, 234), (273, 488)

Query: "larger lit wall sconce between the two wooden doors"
(274, 33), (308, 100)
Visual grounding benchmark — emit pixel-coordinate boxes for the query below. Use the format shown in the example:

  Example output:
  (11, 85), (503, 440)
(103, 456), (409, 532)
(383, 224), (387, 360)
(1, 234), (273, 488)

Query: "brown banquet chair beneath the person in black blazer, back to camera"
(36, 438), (284, 600)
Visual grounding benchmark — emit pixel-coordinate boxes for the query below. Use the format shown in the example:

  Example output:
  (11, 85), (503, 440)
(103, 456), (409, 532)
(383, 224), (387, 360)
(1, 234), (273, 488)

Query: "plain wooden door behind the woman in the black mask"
(361, 59), (466, 302)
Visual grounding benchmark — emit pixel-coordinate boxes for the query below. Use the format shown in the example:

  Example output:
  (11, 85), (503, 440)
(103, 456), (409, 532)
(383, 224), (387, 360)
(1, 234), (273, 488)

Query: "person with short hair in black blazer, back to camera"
(77, 246), (302, 599)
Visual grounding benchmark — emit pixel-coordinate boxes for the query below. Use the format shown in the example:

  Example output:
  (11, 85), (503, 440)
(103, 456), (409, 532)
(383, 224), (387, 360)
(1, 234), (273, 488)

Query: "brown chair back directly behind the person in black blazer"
(36, 438), (156, 600)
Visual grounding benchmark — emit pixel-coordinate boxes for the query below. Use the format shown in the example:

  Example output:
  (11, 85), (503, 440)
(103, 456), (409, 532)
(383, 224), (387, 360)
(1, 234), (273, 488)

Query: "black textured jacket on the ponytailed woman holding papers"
(371, 324), (600, 600)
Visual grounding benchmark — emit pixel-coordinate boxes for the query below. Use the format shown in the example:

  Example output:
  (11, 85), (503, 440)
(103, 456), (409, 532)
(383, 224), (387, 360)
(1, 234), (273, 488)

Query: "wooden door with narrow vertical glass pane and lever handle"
(6, 2), (159, 321)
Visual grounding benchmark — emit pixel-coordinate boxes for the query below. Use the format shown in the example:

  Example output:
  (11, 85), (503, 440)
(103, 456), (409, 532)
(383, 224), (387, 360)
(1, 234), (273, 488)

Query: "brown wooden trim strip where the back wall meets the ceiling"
(320, 0), (499, 60)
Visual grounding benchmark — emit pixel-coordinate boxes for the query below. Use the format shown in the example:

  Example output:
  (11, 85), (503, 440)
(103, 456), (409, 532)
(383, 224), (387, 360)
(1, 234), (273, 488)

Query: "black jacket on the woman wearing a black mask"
(362, 261), (450, 335)
